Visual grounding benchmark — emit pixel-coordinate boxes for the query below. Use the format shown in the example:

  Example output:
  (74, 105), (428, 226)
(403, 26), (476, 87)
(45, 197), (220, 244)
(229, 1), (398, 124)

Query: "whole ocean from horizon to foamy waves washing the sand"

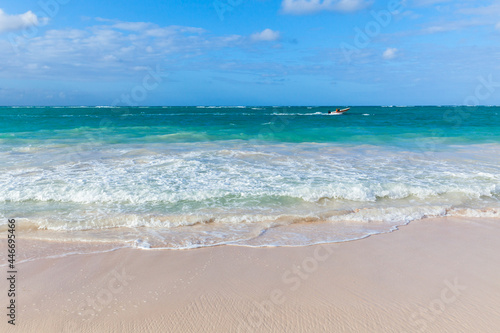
(0, 106), (500, 255)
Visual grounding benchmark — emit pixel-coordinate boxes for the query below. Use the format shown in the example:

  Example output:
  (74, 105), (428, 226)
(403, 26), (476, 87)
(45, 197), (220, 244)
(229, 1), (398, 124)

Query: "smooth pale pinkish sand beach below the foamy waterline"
(1, 214), (500, 332)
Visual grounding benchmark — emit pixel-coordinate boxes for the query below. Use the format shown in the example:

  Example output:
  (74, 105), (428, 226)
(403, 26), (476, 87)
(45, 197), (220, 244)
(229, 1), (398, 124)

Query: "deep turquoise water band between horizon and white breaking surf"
(0, 107), (500, 148)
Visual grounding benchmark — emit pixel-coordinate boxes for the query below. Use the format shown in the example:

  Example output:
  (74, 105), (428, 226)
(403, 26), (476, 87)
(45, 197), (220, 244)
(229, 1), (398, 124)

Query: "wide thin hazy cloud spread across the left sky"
(0, 19), (244, 78)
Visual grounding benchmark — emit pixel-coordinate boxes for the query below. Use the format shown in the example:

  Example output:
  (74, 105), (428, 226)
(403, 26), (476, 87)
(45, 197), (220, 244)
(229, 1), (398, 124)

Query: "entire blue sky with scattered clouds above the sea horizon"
(0, 0), (500, 106)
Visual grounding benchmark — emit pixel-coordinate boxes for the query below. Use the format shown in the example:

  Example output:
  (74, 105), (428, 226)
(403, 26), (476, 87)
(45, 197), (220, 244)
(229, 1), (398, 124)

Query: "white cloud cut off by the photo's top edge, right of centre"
(281, 0), (372, 15)
